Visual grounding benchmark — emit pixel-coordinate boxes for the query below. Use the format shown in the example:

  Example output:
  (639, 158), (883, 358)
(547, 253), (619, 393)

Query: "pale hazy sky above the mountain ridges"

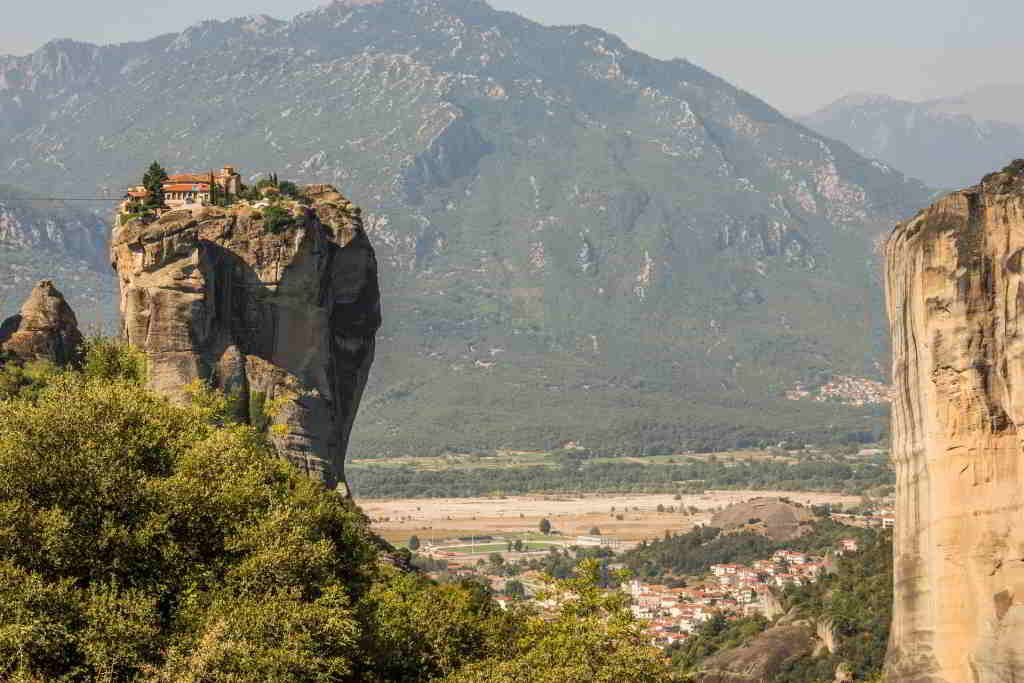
(0, 0), (1024, 115)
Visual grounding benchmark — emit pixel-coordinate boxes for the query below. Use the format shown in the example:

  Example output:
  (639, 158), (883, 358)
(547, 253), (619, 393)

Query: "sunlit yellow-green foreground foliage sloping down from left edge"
(0, 342), (670, 683)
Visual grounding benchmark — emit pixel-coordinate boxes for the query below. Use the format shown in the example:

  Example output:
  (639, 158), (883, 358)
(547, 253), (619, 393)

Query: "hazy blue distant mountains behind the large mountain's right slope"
(801, 86), (1024, 189)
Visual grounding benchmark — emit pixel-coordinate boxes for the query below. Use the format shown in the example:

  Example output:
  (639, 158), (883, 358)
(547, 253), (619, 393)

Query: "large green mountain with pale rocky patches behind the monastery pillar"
(0, 0), (931, 456)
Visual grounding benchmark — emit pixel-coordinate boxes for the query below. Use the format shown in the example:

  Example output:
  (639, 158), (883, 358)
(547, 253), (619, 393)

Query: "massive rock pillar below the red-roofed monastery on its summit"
(111, 185), (381, 493)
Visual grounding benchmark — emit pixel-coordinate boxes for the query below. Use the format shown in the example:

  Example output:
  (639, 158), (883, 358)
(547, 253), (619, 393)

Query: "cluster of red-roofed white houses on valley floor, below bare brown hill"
(623, 539), (859, 646)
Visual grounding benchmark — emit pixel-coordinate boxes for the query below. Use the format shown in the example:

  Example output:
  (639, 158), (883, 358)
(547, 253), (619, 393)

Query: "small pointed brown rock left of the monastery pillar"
(0, 280), (82, 366)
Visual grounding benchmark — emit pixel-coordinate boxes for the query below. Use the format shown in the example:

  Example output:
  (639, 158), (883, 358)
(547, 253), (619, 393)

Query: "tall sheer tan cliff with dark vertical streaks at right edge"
(886, 162), (1024, 683)
